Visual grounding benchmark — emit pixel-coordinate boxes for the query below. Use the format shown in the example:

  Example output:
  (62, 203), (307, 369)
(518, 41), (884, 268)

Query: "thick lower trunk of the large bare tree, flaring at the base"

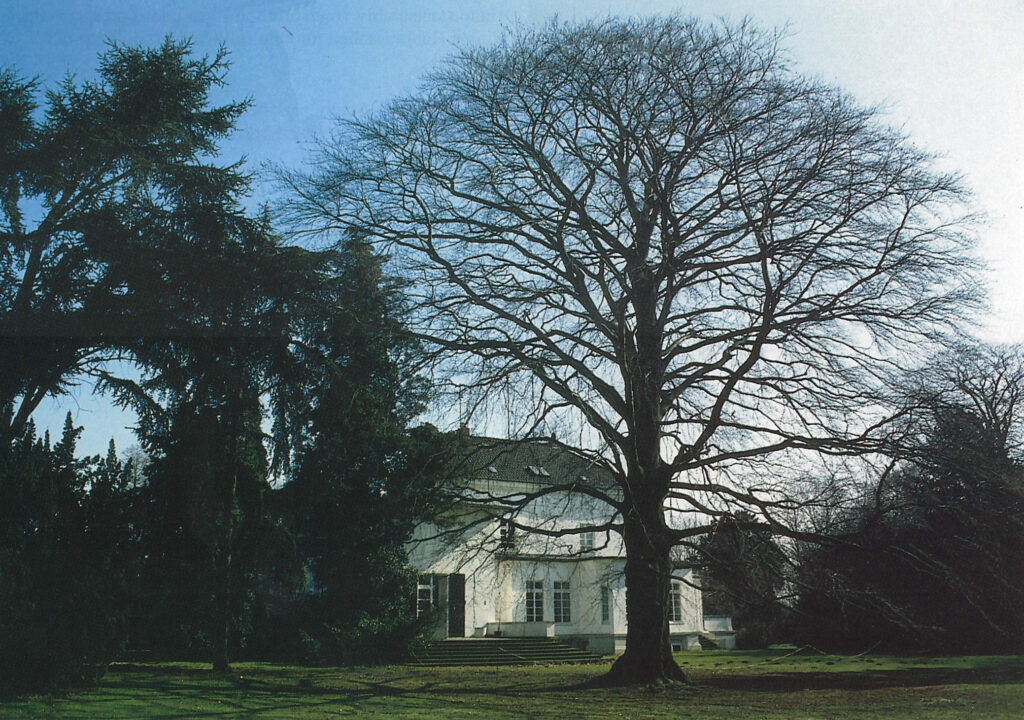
(598, 481), (686, 685)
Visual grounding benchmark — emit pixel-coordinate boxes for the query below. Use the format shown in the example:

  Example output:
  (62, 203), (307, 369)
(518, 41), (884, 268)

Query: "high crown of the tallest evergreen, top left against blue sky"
(0, 39), (266, 441)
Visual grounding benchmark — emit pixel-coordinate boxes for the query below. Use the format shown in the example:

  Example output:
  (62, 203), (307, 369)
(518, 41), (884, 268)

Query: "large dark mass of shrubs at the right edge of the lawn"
(792, 348), (1024, 652)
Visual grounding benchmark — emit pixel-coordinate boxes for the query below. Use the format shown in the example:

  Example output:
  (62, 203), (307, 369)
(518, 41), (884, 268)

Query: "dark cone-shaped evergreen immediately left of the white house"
(282, 238), (456, 662)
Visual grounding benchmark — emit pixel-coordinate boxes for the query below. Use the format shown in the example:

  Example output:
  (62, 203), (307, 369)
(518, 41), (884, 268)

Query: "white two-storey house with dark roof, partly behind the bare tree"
(410, 437), (735, 653)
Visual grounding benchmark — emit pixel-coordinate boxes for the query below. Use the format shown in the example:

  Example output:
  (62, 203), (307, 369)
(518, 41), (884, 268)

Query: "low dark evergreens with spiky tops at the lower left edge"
(0, 414), (134, 693)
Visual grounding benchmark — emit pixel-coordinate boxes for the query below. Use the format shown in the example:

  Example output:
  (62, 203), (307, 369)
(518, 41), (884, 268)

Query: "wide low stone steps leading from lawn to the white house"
(411, 637), (601, 667)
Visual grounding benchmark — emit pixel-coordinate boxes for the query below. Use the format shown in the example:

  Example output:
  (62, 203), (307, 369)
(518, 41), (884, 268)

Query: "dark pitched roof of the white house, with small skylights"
(460, 436), (615, 490)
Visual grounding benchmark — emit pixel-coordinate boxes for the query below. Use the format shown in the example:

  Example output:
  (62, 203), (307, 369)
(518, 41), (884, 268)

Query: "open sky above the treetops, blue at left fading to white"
(0, 0), (1024, 453)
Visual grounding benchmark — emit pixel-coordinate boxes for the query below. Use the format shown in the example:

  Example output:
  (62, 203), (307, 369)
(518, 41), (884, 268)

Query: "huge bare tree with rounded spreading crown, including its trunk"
(285, 17), (976, 682)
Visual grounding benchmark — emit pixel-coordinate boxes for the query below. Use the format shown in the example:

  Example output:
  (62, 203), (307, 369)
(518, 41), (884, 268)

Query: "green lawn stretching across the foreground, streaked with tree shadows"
(0, 649), (1024, 720)
